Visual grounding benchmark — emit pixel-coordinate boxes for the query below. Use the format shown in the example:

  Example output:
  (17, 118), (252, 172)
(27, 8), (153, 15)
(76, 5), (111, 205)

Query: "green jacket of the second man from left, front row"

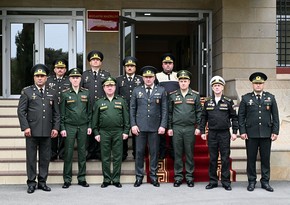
(60, 88), (92, 130)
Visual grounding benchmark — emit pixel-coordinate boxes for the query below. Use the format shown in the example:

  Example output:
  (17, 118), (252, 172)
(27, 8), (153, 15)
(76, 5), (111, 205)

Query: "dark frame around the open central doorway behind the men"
(120, 9), (212, 95)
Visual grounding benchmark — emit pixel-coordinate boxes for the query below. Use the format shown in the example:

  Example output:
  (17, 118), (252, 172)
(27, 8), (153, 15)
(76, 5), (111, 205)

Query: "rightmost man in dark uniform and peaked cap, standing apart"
(238, 72), (280, 192)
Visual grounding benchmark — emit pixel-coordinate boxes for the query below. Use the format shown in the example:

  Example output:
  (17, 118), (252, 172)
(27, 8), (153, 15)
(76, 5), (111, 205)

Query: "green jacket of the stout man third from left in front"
(92, 96), (130, 136)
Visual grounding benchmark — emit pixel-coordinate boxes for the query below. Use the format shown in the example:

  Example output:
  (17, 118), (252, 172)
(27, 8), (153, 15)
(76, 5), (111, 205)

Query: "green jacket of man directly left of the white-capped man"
(168, 88), (202, 129)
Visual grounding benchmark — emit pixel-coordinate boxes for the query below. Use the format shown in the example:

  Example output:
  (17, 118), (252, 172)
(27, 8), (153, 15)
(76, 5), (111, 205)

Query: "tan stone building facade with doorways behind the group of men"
(0, 0), (290, 179)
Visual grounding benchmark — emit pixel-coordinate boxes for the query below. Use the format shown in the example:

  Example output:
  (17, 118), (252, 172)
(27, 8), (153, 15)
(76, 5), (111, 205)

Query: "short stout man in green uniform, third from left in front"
(93, 77), (130, 188)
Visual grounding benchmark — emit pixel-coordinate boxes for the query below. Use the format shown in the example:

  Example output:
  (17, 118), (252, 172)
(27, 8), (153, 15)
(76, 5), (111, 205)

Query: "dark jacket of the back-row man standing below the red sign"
(81, 69), (110, 106)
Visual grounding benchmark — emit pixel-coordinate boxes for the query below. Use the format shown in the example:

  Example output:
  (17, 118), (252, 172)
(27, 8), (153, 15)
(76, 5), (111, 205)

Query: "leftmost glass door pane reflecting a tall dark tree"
(8, 21), (39, 95)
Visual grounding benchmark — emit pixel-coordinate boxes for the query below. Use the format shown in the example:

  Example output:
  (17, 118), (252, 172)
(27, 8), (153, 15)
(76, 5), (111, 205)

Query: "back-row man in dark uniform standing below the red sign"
(81, 50), (111, 160)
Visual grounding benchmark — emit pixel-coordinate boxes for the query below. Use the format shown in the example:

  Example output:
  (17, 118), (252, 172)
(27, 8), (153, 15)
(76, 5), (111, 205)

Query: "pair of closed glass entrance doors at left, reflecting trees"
(3, 20), (77, 98)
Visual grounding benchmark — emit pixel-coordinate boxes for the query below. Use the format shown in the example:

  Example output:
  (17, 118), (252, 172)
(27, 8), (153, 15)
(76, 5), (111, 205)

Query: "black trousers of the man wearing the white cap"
(208, 129), (231, 186)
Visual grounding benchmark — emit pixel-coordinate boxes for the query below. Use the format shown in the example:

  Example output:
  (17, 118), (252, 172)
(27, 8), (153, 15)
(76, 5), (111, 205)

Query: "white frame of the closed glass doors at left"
(0, 8), (86, 98)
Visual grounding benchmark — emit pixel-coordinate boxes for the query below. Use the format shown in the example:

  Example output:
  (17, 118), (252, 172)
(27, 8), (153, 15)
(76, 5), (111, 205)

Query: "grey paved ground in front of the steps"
(0, 181), (290, 205)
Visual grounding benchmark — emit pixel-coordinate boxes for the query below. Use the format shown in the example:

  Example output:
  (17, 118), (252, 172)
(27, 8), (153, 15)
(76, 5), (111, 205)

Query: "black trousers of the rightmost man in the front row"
(246, 138), (272, 183)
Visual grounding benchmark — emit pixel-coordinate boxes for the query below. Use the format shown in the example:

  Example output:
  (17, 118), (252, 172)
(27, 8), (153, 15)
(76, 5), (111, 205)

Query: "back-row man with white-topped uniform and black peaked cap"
(156, 53), (179, 159)
